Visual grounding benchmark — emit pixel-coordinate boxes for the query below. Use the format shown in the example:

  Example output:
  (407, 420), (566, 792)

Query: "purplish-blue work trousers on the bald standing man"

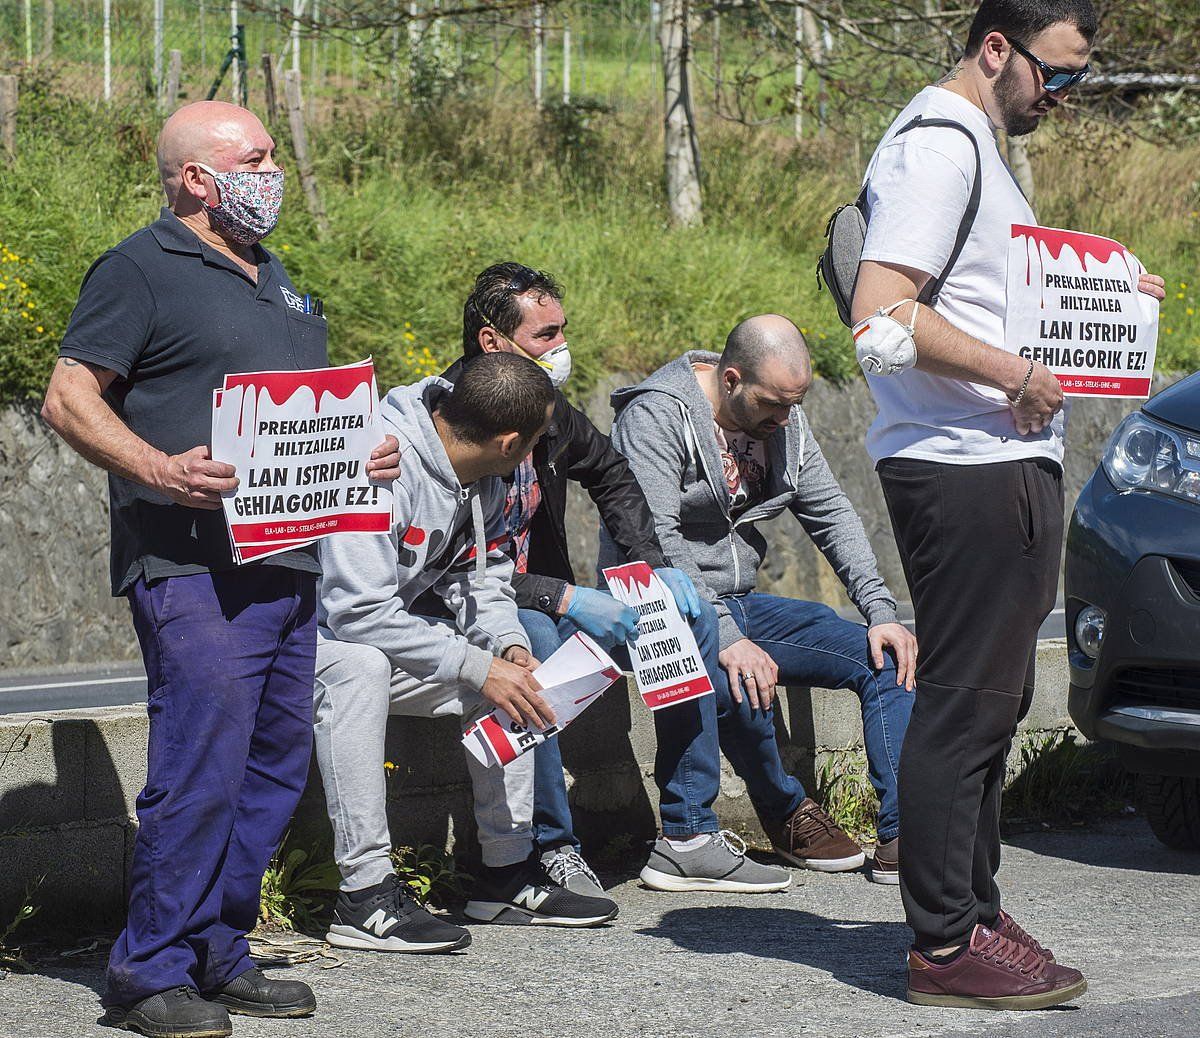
(103, 565), (317, 1006)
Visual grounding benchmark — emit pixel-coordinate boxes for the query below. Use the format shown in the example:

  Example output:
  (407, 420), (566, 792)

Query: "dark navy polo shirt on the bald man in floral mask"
(59, 209), (329, 595)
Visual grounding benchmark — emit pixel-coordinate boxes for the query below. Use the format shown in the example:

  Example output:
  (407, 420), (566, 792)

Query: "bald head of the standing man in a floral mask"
(157, 101), (275, 206)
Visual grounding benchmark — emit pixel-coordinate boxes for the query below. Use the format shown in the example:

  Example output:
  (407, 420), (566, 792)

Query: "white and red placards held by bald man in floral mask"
(212, 360), (391, 564)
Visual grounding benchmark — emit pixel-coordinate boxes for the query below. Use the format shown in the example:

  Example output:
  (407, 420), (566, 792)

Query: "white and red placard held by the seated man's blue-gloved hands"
(604, 563), (713, 710)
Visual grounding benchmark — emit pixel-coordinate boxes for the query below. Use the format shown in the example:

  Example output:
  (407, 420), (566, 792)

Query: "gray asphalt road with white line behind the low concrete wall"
(0, 608), (1063, 714)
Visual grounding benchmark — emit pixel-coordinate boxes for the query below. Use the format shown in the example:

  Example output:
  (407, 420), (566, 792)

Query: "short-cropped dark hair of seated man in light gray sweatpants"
(438, 353), (554, 444)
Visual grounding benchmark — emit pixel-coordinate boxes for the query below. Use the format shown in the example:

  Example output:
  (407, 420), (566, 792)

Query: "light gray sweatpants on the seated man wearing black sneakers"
(313, 636), (533, 890)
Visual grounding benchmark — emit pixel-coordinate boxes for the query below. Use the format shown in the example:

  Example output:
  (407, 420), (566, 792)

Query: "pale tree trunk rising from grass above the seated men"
(659, 0), (702, 227)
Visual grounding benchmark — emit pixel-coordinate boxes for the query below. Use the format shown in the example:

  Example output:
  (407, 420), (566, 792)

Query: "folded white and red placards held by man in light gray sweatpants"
(462, 631), (620, 768)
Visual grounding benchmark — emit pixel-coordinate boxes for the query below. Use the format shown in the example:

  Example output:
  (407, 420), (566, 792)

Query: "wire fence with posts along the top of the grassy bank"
(0, 0), (1200, 138)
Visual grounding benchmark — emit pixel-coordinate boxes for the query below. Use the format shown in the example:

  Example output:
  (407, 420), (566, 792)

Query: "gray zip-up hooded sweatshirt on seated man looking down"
(600, 350), (896, 649)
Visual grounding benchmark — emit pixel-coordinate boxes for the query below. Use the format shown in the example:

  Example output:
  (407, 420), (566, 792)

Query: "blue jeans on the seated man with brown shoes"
(718, 592), (913, 840)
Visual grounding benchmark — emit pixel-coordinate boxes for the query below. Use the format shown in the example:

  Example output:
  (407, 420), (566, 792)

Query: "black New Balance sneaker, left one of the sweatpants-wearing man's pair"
(325, 875), (470, 954)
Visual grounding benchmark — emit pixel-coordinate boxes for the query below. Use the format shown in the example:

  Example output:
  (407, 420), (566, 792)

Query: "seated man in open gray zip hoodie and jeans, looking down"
(601, 314), (917, 883)
